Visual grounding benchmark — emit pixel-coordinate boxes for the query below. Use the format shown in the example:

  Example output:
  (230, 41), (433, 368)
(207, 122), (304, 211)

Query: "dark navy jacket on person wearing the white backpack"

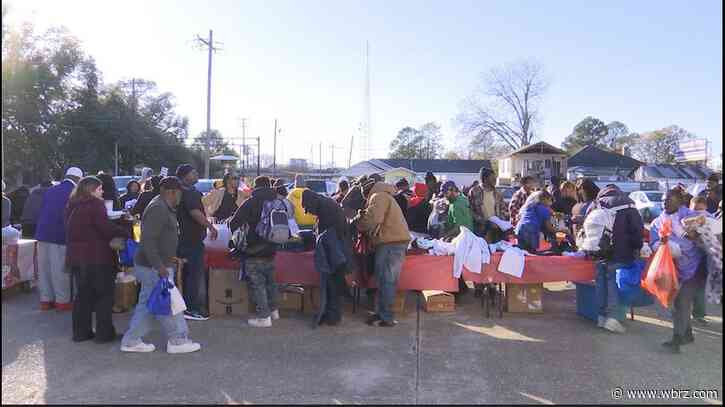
(596, 188), (644, 264)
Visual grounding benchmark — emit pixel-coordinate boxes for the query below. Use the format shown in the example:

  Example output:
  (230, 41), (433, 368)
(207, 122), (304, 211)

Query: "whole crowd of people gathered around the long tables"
(3, 164), (722, 353)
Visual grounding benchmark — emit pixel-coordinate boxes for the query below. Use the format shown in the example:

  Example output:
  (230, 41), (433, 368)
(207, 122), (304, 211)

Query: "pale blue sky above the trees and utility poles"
(4, 0), (722, 165)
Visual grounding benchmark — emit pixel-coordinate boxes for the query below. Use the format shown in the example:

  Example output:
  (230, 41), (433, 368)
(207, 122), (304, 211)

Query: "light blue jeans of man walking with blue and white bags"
(121, 265), (189, 347)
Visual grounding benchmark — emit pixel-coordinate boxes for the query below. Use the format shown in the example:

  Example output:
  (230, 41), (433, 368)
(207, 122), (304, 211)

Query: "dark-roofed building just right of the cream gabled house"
(566, 146), (642, 181)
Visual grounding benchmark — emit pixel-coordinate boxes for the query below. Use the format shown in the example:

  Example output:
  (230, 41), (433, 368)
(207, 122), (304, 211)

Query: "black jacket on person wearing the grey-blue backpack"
(229, 188), (277, 257)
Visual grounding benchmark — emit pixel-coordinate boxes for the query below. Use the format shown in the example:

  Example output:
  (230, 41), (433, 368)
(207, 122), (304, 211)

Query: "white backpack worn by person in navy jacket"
(576, 204), (634, 259)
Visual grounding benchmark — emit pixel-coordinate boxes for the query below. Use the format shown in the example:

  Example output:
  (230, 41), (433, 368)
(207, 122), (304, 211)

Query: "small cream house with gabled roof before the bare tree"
(498, 141), (567, 185)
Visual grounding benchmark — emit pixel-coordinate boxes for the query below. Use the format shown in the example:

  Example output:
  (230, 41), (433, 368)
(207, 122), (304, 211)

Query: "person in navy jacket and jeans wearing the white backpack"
(593, 186), (645, 333)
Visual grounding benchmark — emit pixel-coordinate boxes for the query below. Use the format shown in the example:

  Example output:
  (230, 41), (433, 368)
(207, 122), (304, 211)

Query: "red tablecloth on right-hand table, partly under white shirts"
(460, 252), (596, 284)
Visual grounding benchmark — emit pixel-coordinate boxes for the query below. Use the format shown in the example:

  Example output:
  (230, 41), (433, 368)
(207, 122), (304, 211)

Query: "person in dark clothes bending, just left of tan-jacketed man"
(302, 190), (352, 326)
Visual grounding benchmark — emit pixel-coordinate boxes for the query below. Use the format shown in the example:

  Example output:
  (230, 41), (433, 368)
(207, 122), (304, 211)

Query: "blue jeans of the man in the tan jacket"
(375, 244), (408, 322)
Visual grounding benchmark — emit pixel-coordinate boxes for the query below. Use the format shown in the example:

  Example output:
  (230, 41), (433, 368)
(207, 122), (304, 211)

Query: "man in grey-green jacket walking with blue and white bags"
(121, 177), (201, 353)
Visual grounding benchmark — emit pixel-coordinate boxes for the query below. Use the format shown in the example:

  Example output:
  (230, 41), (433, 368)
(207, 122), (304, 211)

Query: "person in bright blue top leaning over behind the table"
(515, 191), (556, 252)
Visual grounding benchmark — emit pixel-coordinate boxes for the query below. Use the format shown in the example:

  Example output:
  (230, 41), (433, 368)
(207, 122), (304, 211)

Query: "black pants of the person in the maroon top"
(72, 265), (116, 342)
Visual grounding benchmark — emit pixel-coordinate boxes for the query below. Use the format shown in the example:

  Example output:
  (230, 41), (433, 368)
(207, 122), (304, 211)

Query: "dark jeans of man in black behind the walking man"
(177, 242), (207, 312)
